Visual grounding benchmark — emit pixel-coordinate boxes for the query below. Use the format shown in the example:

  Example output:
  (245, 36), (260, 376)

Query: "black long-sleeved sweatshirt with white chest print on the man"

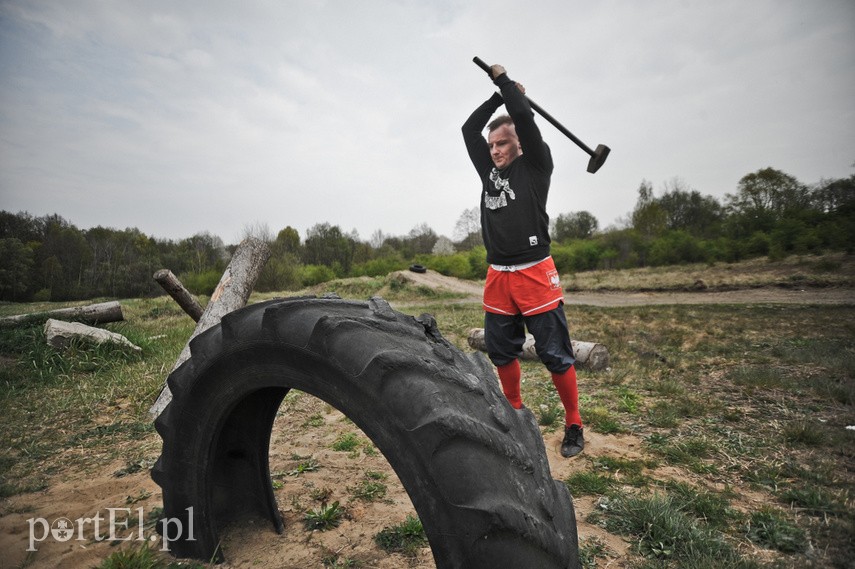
(463, 74), (554, 265)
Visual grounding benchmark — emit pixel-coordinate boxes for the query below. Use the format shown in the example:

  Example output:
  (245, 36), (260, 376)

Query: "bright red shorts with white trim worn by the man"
(484, 257), (564, 316)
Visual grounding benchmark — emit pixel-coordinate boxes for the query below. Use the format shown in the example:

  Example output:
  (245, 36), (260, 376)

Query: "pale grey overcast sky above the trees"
(0, 0), (855, 243)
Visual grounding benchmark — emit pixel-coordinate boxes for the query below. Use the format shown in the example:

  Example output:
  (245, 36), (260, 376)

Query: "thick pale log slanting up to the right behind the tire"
(148, 237), (270, 419)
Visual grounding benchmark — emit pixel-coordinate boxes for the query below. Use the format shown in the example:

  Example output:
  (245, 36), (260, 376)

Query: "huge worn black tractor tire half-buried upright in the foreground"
(151, 298), (579, 569)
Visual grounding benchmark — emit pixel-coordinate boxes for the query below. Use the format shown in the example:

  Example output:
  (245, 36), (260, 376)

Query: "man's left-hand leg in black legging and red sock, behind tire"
(484, 312), (525, 409)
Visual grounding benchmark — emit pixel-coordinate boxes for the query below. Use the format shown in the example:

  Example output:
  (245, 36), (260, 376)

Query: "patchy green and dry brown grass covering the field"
(0, 254), (855, 569)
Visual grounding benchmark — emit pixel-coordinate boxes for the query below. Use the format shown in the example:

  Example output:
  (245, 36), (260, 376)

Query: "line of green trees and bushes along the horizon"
(0, 168), (855, 302)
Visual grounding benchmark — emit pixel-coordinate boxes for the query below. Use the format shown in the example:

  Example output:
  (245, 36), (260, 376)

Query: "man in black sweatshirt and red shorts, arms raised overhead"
(463, 65), (585, 457)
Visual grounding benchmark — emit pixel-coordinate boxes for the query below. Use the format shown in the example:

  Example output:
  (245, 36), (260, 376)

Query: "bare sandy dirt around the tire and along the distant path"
(0, 272), (855, 569)
